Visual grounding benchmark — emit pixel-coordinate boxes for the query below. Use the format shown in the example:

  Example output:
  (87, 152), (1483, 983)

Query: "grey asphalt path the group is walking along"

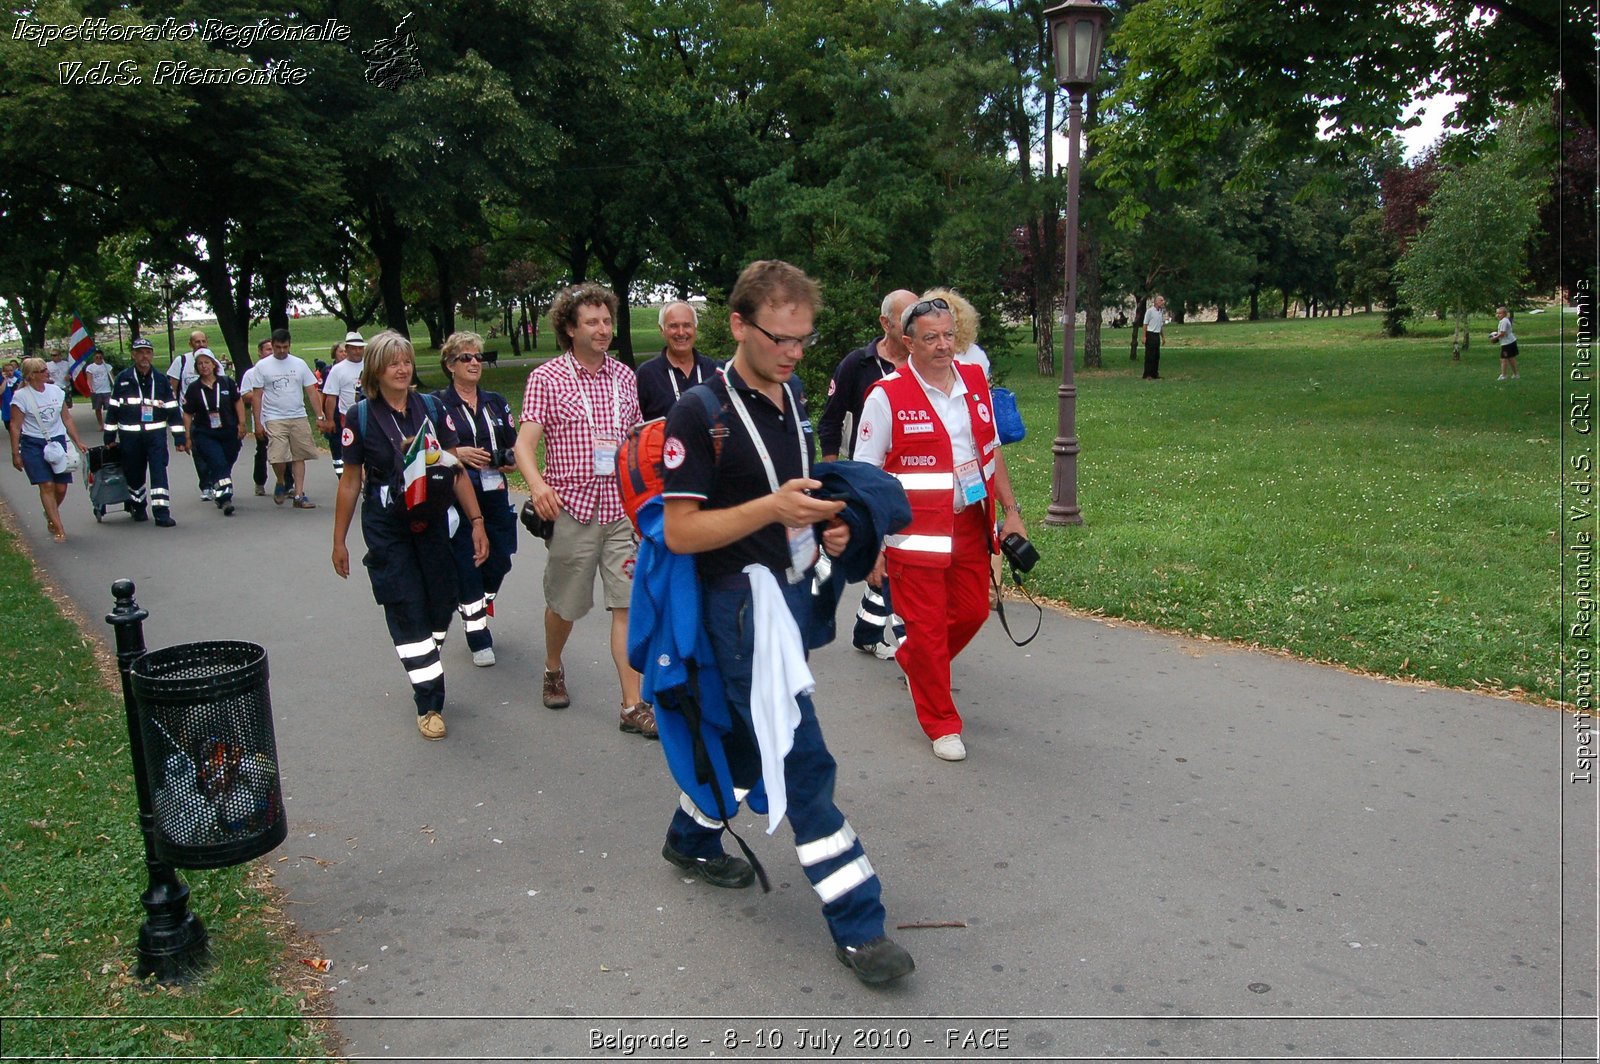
(0, 406), (1597, 1061)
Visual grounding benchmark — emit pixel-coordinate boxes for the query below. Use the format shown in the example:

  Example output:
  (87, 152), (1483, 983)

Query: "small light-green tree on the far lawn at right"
(1398, 109), (1547, 358)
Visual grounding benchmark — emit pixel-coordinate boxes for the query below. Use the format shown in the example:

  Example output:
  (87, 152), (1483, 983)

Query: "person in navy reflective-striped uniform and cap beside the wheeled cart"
(106, 336), (189, 528)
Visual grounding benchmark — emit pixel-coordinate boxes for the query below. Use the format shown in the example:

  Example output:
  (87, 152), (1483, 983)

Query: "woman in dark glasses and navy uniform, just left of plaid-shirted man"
(434, 333), (517, 667)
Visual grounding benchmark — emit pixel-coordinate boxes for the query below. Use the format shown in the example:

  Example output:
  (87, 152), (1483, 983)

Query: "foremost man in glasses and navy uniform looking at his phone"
(662, 261), (915, 986)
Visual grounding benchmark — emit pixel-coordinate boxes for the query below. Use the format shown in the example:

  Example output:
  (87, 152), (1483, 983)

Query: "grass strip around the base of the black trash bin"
(0, 528), (326, 1059)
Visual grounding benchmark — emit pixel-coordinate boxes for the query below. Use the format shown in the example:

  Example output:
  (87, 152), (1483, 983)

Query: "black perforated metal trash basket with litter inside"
(131, 640), (288, 869)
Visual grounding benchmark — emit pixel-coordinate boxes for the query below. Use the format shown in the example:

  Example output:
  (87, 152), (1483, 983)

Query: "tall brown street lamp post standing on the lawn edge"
(1045, 0), (1110, 525)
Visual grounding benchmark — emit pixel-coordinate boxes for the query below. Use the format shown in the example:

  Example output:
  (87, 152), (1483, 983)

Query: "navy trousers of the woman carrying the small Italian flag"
(362, 494), (456, 717)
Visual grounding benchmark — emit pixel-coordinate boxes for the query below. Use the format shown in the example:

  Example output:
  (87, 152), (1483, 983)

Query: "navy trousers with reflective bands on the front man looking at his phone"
(667, 574), (885, 946)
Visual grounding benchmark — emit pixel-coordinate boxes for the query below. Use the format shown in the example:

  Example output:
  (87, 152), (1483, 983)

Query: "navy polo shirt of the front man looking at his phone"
(661, 365), (816, 581)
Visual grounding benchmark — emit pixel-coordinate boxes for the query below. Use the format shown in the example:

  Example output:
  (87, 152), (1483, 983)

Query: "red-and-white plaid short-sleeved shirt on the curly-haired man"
(522, 354), (640, 525)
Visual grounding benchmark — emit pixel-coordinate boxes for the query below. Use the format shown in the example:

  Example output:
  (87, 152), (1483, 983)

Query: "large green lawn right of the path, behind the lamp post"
(1005, 314), (1571, 698)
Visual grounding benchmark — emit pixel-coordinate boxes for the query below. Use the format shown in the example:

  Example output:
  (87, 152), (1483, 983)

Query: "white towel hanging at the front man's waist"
(744, 565), (816, 835)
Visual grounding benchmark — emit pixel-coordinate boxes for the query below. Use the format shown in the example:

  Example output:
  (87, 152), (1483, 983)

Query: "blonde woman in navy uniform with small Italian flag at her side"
(333, 331), (490, 739)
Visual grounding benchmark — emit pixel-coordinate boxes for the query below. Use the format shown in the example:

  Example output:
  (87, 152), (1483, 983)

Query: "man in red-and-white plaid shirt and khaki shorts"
(515, 283), (656, 739)
